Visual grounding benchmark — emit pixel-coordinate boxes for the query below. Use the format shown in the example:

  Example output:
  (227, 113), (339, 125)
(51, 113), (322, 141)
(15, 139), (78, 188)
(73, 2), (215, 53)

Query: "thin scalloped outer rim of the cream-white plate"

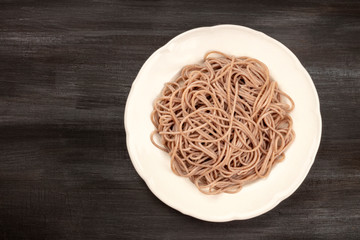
(124, 24), (322, 222)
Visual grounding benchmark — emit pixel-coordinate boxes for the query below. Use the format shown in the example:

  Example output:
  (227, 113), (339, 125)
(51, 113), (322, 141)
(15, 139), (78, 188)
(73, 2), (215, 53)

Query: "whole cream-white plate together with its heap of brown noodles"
(125, 25), (321, 222)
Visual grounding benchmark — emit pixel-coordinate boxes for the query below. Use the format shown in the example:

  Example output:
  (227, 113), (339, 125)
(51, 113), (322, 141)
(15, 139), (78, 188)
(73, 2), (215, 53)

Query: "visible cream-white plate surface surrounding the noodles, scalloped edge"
(125, 25), (321, 222)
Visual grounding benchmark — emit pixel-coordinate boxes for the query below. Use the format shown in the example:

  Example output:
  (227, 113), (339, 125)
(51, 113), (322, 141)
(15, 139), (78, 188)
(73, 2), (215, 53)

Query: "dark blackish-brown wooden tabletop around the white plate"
(0, 0), (360, 239)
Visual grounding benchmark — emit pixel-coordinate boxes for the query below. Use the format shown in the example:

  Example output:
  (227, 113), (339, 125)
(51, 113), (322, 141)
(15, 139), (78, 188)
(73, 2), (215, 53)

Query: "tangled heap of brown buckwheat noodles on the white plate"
(151, 51), (295, 194)
